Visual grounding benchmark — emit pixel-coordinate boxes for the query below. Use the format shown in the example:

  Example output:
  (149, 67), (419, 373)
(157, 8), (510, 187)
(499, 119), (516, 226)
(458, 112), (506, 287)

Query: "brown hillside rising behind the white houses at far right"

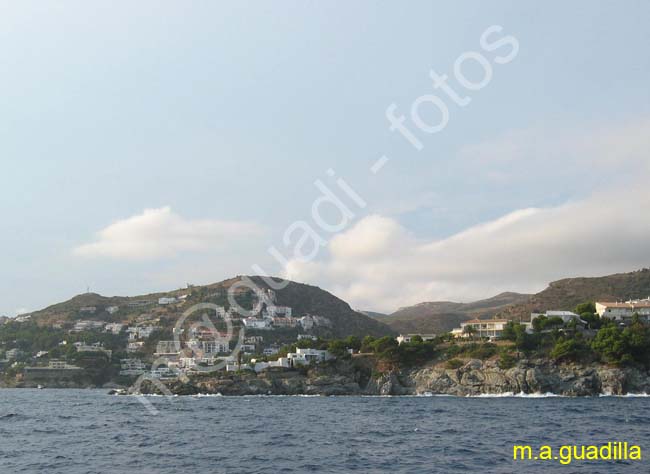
(499, 268), (650, 321)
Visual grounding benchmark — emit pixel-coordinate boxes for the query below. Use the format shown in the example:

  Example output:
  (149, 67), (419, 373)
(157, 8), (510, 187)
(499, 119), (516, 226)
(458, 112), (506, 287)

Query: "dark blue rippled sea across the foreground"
(0, 390), (650, 474)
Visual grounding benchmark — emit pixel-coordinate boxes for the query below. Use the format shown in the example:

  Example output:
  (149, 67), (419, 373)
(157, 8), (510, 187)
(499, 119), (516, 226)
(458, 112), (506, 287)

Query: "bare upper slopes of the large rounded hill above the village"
(27, 276), (394, 337)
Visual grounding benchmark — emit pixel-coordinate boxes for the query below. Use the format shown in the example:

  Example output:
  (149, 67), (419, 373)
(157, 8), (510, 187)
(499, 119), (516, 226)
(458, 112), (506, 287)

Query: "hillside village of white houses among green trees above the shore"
(0, 270), (650, 387)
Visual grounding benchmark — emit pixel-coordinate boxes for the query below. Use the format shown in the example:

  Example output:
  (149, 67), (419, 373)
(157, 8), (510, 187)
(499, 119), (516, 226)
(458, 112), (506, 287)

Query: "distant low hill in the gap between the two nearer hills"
(378, 293), (530, 333)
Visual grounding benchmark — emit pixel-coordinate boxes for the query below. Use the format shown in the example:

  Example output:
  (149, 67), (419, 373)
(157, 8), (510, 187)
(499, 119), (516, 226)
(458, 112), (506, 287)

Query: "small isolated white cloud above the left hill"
(73, 207), (261, 260)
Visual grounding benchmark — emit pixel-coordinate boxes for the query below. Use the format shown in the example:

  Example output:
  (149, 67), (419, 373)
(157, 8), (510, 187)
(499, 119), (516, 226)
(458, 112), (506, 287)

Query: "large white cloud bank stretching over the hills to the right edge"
(285, 121), (650, 311)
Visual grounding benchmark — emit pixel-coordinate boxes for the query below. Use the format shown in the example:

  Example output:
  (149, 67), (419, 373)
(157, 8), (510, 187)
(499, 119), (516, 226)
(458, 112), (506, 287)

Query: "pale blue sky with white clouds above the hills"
(0, 0), (650, 316)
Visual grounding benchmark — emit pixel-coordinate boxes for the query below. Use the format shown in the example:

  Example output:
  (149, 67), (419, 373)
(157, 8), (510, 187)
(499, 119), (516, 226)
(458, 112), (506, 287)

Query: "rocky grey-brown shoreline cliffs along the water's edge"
(132, 360), (650, 397)
